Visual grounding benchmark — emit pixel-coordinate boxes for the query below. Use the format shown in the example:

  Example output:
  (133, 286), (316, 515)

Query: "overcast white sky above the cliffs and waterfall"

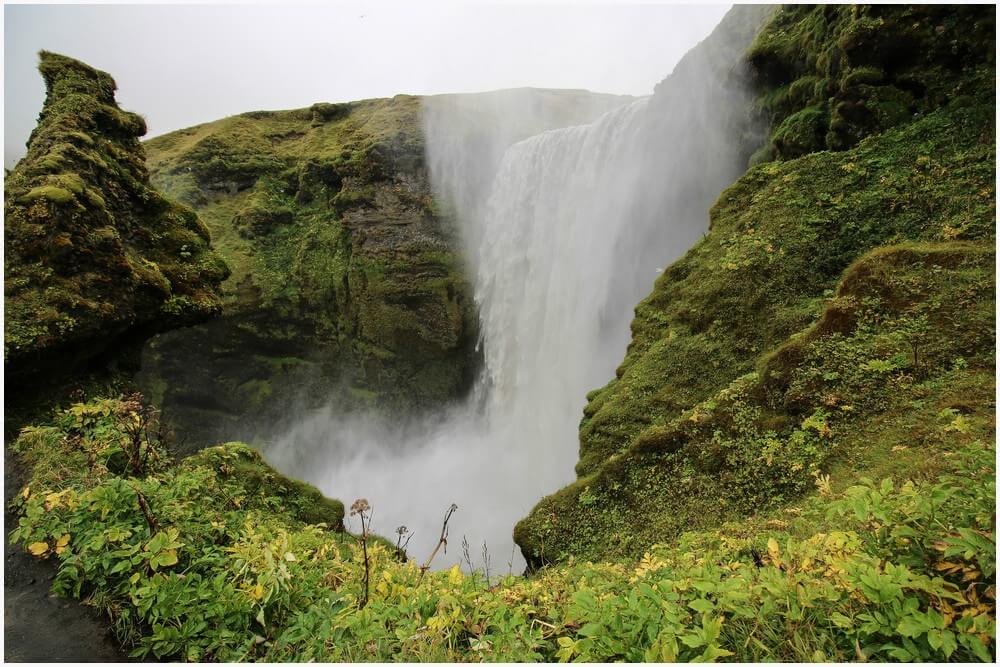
(4, 2), (729, 166)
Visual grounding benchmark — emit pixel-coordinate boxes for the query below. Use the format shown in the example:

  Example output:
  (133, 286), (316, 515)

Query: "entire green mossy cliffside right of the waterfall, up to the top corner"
(515, 7), (995, 564)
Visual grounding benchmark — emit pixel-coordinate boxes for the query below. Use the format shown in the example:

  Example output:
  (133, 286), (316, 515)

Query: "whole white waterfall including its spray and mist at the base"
(266, 5), (763, 571)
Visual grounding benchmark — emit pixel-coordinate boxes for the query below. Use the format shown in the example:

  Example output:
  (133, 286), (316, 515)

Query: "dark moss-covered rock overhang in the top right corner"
(749, 5), (995, 159)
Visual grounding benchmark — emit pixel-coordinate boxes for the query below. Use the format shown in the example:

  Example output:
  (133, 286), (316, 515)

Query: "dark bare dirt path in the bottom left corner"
(3, 451), (127, 662)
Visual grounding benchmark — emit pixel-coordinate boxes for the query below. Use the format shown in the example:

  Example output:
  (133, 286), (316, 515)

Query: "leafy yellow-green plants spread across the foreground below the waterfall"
(11, 400), (996, 661)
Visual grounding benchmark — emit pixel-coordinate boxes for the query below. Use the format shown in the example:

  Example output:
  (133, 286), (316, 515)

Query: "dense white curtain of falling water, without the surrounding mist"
(476, 99), (655, 412)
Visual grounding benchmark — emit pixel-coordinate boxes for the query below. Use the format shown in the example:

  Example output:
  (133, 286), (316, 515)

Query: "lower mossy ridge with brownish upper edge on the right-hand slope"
(515, 242), (995, 563)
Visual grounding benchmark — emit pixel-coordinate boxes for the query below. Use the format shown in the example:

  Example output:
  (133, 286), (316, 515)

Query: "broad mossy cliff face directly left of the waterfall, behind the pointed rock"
(140, 91), (620, 444)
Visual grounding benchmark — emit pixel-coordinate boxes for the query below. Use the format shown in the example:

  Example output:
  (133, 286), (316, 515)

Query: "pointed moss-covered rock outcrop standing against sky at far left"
(4, 52), (229, 379)
